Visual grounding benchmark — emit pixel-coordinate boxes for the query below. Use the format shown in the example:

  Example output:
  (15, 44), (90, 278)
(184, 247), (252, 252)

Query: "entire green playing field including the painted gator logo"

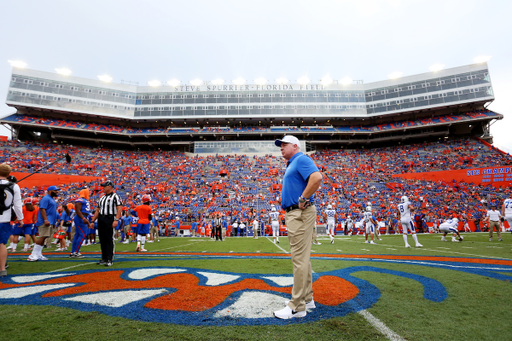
(0, 233), (512, 340)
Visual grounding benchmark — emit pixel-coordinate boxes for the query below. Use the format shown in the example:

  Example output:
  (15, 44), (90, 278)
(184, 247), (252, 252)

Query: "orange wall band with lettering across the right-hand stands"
(393, 165), (512, 186)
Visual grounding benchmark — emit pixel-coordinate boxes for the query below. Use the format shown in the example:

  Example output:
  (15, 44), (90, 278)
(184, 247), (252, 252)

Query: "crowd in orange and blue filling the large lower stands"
(0, 135), (512, 231)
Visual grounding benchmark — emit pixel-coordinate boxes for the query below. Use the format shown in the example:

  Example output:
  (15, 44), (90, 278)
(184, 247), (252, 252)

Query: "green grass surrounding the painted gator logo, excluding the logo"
(0, 233), (512, 341)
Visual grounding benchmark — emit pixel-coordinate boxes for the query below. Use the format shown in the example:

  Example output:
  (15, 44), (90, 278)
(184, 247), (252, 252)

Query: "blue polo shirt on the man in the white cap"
(281, 152), (318, 209)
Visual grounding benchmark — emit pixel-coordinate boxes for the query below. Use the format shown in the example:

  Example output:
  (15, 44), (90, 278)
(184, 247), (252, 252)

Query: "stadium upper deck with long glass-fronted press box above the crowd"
(0, 63), (502, 150)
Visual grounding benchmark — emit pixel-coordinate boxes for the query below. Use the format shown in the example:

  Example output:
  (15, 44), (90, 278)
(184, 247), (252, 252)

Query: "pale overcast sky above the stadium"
(0, 0), (512, 152)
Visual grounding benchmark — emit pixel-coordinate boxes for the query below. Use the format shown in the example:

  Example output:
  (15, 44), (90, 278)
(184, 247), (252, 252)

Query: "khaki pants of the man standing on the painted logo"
(286, 206), (316, 311)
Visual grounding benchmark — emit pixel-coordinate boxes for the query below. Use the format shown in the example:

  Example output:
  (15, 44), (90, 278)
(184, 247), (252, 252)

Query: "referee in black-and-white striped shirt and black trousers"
(91, 180), (123, 266)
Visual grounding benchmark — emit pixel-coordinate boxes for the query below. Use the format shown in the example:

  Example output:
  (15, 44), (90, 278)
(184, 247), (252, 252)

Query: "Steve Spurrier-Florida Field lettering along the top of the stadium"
(174, 84), (324, 92)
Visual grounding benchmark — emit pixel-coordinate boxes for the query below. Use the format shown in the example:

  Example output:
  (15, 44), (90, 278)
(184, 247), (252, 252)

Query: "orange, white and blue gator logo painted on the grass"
(0, 266), (447, 326)
